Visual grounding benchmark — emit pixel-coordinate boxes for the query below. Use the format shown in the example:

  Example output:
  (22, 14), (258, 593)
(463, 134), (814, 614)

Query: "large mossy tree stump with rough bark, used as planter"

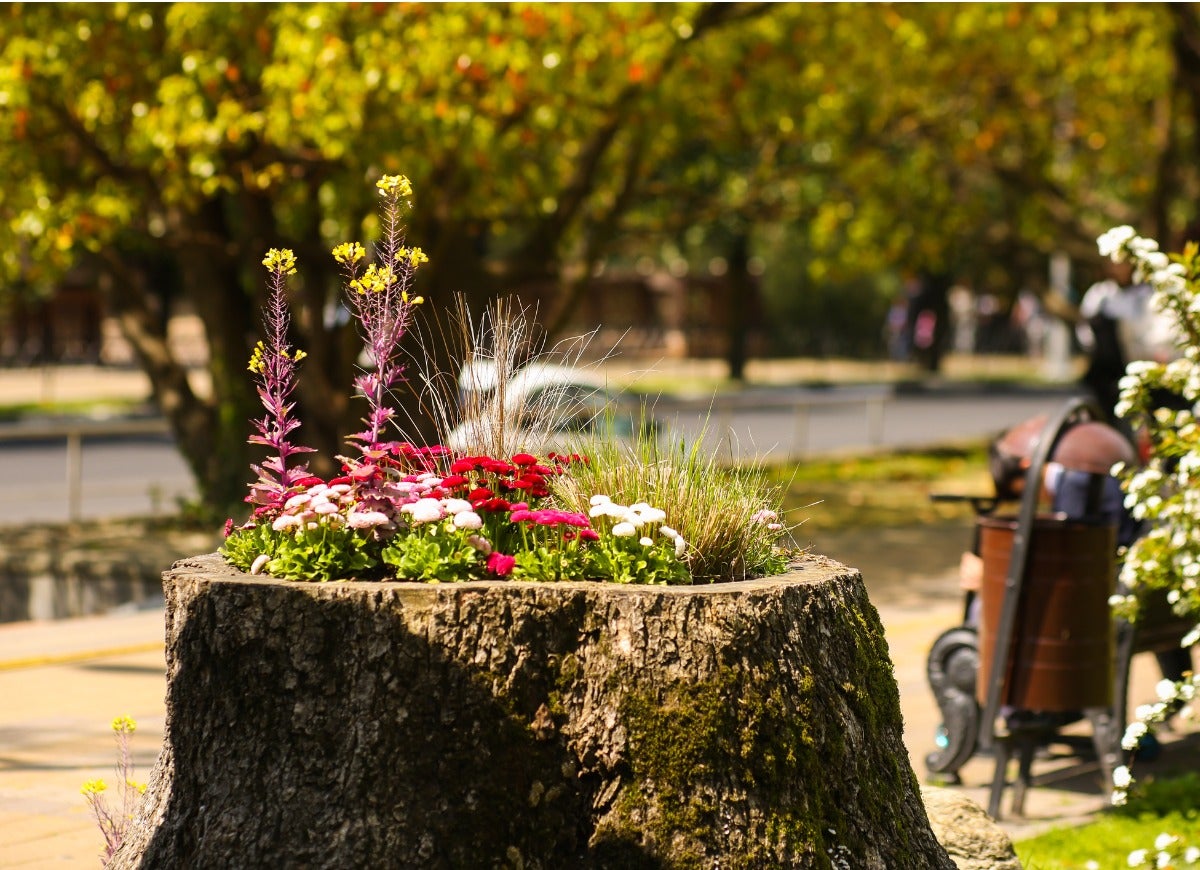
(109, 554), (954, 870)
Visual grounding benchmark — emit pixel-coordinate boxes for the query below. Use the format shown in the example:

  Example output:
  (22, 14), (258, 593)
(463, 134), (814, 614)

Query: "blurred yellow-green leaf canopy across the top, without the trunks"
(0, 4), (1183, 295)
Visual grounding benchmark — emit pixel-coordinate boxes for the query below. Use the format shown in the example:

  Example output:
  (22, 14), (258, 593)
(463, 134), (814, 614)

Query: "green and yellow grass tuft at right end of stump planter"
(552, 417), (796, 583)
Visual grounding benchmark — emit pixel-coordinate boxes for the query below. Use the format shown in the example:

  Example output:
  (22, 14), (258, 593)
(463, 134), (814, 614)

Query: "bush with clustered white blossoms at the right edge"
(1098, 227), (1200, 840)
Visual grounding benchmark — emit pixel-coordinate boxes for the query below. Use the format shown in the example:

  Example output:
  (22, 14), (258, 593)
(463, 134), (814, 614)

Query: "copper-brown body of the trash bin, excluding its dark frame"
(976, 516), (1116, 712)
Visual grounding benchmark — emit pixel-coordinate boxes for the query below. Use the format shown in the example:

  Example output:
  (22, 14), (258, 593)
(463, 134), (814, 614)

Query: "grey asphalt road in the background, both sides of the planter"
(0, 388), (1084, 524)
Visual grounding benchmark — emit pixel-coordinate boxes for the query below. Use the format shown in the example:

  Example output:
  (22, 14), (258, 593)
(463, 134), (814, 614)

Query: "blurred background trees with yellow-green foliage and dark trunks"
(0, 4), (1200, 505)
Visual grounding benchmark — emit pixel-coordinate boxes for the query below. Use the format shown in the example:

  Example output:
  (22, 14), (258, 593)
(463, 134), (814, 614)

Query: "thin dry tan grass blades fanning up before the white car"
(414, 296), (608, 456)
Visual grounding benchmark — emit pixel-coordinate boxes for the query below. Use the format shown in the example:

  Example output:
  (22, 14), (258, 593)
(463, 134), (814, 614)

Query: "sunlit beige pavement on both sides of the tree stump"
(0, 559), (1194, 870)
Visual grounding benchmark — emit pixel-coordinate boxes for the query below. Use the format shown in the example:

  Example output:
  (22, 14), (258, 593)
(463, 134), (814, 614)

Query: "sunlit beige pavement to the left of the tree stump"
(0, 607), (166, 870)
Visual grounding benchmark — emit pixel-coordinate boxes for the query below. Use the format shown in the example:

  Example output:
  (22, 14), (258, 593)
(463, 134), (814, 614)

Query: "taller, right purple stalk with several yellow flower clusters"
(334, 175), (428, 462)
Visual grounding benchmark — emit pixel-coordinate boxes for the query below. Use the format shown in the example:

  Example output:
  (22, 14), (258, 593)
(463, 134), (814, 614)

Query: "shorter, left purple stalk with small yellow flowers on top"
(246, 248), (313, 506)
